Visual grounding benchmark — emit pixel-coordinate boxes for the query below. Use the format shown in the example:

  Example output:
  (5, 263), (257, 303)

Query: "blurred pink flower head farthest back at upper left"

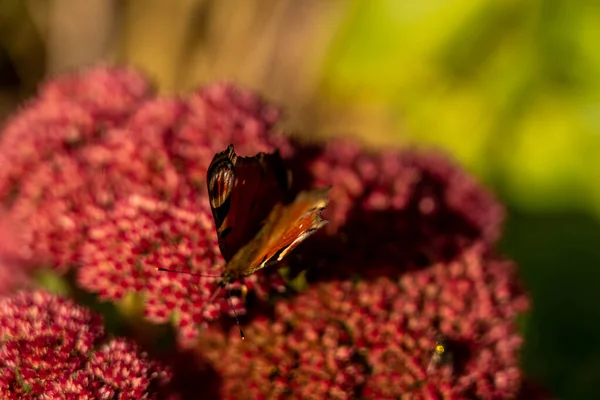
(0, 68), (150, 203)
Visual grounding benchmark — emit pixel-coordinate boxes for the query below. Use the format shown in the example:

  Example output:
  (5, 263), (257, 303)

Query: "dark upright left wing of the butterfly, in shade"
(206, 145), (288, 261)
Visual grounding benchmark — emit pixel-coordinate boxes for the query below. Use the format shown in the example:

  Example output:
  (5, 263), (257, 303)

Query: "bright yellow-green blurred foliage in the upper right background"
(325, 0), (600, 211)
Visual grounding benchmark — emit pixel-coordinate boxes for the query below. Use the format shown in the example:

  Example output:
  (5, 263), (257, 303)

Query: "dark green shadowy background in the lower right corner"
(501, 207), (600, 399)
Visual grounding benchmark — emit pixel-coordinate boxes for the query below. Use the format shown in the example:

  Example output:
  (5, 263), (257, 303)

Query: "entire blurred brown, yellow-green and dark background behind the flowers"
(0, 0), (600, 399)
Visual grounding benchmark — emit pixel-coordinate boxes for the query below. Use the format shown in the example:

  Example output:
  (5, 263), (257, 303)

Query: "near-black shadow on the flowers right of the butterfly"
(286, 144), (500, 282)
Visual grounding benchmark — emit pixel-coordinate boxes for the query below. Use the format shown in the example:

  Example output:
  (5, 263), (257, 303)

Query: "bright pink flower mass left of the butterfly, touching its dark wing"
(0, 68), (287, 342)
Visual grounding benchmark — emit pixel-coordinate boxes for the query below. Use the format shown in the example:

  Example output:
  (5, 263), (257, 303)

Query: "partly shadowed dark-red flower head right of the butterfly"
(291, 140), (504, 277)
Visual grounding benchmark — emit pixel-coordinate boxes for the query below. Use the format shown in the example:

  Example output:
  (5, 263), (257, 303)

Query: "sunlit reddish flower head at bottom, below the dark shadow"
(199, 244), (527, 399)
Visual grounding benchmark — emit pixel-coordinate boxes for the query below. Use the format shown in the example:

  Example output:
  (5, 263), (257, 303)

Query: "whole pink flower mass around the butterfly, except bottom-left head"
(0, 68), (540, 399)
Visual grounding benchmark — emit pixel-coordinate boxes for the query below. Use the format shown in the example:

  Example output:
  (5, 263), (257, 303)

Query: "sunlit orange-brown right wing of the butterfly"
(225, 188), (329, 279)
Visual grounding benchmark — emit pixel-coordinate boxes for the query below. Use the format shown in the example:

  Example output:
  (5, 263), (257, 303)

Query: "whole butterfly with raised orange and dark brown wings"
(207, 145), (329, 286)
